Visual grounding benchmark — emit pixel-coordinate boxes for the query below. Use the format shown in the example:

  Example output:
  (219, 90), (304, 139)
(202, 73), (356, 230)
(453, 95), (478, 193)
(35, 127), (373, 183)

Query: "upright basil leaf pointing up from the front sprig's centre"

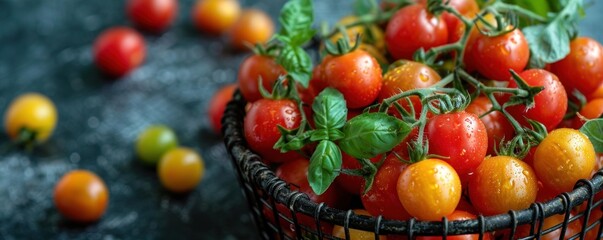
(312, 87), (348, 130)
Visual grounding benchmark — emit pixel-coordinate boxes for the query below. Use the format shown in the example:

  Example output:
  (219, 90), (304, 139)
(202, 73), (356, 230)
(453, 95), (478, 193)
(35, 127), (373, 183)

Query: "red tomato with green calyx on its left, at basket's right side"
(503, 69), (567, 131)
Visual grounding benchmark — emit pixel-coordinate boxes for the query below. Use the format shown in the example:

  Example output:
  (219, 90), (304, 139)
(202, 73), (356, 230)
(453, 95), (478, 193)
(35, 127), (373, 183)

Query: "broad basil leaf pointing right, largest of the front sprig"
(339, 113), (411, 158)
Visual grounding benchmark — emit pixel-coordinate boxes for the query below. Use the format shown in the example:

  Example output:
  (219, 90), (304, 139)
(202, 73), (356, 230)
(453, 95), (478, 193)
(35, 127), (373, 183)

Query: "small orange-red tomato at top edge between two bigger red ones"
(418, 0), (479, 43)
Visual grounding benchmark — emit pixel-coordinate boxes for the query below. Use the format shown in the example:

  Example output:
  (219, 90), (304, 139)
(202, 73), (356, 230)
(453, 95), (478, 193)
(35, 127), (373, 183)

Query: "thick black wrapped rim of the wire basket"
(222, 89), (603, 239)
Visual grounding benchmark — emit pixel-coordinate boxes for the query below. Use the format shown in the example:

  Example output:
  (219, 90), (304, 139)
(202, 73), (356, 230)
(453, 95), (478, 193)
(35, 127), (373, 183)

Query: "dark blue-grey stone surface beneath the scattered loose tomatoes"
(0, 0), (603, 240)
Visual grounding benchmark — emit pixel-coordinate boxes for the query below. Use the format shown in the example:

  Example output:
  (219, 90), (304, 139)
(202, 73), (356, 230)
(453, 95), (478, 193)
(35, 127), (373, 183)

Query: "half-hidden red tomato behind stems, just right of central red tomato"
(465, 96), (515, 155)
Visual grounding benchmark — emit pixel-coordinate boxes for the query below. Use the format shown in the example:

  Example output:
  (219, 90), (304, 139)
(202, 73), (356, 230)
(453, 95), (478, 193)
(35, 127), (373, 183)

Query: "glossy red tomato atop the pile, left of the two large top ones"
(385, 4), (448, 59)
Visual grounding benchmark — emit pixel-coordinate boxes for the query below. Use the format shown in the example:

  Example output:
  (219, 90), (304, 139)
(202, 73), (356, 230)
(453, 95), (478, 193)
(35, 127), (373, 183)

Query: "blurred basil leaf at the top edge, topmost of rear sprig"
(279, 0), (314, 46)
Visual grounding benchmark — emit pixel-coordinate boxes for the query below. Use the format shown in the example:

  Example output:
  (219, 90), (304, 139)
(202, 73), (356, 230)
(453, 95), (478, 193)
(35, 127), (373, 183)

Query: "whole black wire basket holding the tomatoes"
(222, 91), (603, 240)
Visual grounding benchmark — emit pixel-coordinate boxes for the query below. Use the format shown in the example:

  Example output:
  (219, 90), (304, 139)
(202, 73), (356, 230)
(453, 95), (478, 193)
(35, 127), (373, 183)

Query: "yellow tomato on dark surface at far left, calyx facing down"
(4, 93), (57, 143)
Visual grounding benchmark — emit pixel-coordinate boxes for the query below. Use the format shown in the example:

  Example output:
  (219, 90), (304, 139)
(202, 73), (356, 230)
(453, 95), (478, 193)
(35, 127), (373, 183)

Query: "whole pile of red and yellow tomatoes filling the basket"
(238, 0), (603, 239)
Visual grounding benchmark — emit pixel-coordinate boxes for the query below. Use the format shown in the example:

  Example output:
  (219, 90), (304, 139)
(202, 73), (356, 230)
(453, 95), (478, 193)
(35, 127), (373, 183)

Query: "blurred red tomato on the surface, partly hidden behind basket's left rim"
(207, 84), (237, 134)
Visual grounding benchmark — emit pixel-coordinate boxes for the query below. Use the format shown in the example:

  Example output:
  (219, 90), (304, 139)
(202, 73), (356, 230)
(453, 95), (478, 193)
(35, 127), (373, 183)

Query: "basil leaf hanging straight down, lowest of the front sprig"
(308, 140), (341, 195)
